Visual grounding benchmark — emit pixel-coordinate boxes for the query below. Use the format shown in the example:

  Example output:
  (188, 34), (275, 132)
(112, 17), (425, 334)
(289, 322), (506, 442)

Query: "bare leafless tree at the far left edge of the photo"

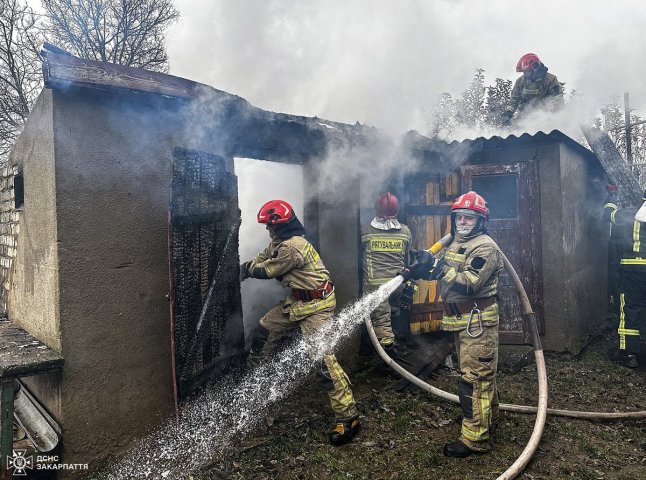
(0, 0), (42, 163)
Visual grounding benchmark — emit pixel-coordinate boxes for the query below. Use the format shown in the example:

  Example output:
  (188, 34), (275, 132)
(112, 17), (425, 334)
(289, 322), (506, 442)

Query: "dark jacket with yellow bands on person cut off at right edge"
(603, 201), (646, 272)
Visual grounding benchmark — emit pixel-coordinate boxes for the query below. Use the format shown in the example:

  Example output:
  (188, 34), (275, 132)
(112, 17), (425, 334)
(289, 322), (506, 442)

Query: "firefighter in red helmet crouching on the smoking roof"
(503, 53), (563, 125)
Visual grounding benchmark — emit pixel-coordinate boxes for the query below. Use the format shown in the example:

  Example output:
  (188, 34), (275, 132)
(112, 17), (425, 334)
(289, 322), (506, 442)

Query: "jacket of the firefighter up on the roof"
(505, 70), (563, 113)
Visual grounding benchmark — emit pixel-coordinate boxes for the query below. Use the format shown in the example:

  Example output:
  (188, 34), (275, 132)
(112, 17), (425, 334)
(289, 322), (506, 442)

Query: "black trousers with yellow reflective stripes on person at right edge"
(617, 269), (646, 355)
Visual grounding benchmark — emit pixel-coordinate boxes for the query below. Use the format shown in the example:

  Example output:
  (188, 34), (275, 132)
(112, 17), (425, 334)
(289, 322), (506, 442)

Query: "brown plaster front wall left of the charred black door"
(54, 91), (177, 463)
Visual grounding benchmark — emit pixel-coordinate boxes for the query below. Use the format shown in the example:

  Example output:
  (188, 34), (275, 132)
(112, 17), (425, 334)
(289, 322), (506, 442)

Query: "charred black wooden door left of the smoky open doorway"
(168, 148), (244, 400)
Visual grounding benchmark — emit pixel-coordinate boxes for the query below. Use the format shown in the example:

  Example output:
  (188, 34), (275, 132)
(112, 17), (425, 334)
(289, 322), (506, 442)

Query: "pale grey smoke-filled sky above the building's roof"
(168, 0), (646, 133)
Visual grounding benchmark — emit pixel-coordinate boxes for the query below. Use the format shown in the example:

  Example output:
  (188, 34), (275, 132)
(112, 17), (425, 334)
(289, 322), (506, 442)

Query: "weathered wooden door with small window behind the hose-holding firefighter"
(461, 161), (544, 344)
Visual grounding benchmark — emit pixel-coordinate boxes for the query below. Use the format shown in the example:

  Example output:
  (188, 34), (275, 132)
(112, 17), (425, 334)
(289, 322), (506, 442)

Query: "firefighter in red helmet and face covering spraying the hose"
(402, 191), (504, 458)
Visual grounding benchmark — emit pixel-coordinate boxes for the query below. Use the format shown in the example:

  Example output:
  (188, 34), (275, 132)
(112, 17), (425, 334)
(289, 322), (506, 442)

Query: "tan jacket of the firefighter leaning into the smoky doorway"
(247, 235), (336, 320)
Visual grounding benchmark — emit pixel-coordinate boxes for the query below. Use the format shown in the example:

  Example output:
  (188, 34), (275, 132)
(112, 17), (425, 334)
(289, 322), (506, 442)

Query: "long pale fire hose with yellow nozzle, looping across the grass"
(365, 235), (646, 480)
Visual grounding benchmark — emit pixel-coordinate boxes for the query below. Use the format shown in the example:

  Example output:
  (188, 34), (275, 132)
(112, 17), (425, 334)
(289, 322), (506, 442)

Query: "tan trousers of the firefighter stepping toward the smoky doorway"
(250, 302), (359, 420)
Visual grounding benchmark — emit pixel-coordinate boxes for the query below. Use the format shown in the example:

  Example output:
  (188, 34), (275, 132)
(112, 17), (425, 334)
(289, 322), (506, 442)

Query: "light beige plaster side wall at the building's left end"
(7, 90), (61, 352)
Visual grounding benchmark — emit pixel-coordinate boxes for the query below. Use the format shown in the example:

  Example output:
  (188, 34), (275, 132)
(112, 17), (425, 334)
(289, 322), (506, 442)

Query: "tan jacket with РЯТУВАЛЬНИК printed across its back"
(361, 225), (412, 289)
